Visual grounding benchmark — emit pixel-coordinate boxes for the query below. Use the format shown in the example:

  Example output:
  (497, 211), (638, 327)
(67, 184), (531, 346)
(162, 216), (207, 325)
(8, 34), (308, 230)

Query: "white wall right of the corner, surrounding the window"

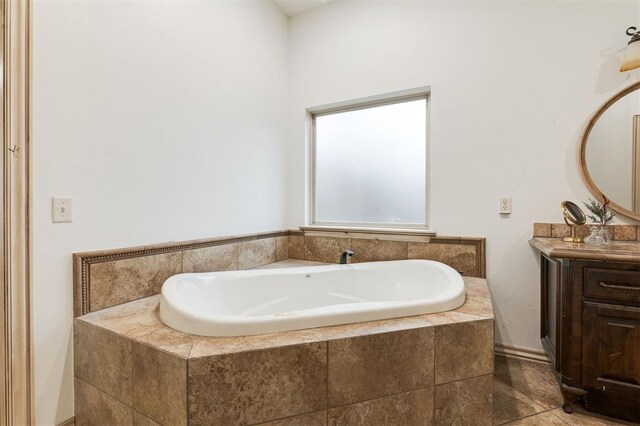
(287, 1), (640, 349)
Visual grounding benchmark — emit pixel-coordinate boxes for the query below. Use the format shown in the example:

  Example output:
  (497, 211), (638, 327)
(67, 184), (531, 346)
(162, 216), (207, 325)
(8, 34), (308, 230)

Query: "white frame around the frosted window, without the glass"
(305, 86), (435, 235)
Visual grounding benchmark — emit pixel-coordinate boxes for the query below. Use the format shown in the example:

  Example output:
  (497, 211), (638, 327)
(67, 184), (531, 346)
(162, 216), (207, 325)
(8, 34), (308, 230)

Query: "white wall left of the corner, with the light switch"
(33, 0), (288, 425)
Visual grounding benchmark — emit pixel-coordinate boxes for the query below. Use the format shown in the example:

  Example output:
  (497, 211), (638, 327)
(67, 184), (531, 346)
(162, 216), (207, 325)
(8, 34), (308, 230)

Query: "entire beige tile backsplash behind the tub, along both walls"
(73, 230), (485, 317)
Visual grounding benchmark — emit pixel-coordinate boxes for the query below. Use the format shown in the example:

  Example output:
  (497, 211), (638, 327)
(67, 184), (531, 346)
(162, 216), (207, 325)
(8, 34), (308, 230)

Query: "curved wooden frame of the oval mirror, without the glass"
(578, 81), (640, 225)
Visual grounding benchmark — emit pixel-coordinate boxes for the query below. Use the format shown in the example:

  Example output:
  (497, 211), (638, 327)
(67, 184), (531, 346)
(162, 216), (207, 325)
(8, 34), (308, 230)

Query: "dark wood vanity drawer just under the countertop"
(584, 268), (640, 304)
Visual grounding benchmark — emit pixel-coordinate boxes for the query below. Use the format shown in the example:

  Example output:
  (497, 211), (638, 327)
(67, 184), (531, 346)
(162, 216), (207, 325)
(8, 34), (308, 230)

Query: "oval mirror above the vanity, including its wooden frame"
(579, 82), (640, 220)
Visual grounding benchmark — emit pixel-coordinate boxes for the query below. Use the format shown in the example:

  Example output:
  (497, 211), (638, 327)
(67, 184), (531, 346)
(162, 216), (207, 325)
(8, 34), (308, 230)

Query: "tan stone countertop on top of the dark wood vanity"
(529, 237), (640, 263)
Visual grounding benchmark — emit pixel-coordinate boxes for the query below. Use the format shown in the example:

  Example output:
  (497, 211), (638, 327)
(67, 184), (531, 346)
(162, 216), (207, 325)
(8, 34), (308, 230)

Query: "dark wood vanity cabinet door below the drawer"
(582, 302), (640, 421)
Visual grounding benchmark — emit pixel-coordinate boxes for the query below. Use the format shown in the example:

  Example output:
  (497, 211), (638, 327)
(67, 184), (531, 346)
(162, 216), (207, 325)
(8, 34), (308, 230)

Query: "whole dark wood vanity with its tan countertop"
(530, 237), (640, 422)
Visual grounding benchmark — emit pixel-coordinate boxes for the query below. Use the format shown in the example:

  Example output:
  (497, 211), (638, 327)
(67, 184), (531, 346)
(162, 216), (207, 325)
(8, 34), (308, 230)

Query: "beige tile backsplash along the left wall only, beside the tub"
(73, 231), (289, 316)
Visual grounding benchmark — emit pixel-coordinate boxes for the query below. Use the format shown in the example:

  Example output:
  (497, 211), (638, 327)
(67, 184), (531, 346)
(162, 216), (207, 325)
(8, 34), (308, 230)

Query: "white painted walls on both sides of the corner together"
(33, 0), (640, 425)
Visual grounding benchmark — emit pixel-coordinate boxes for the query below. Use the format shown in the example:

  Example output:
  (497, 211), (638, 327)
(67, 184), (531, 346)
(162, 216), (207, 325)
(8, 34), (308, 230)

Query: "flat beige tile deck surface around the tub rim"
(74, 260), (494, 358)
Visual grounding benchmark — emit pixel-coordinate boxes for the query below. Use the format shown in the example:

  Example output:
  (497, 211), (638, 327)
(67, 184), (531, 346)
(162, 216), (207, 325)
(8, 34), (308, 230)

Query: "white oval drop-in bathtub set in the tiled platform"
(160, 260), (465, 336)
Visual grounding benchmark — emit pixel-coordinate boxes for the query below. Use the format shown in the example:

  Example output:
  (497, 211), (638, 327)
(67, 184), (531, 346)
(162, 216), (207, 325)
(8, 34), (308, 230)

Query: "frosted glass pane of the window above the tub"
(314, 98), (427, 226)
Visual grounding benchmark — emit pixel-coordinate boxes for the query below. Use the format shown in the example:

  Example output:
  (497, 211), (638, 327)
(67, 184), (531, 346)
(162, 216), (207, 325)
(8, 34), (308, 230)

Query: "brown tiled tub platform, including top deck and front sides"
(74, 260), (494, 425)
